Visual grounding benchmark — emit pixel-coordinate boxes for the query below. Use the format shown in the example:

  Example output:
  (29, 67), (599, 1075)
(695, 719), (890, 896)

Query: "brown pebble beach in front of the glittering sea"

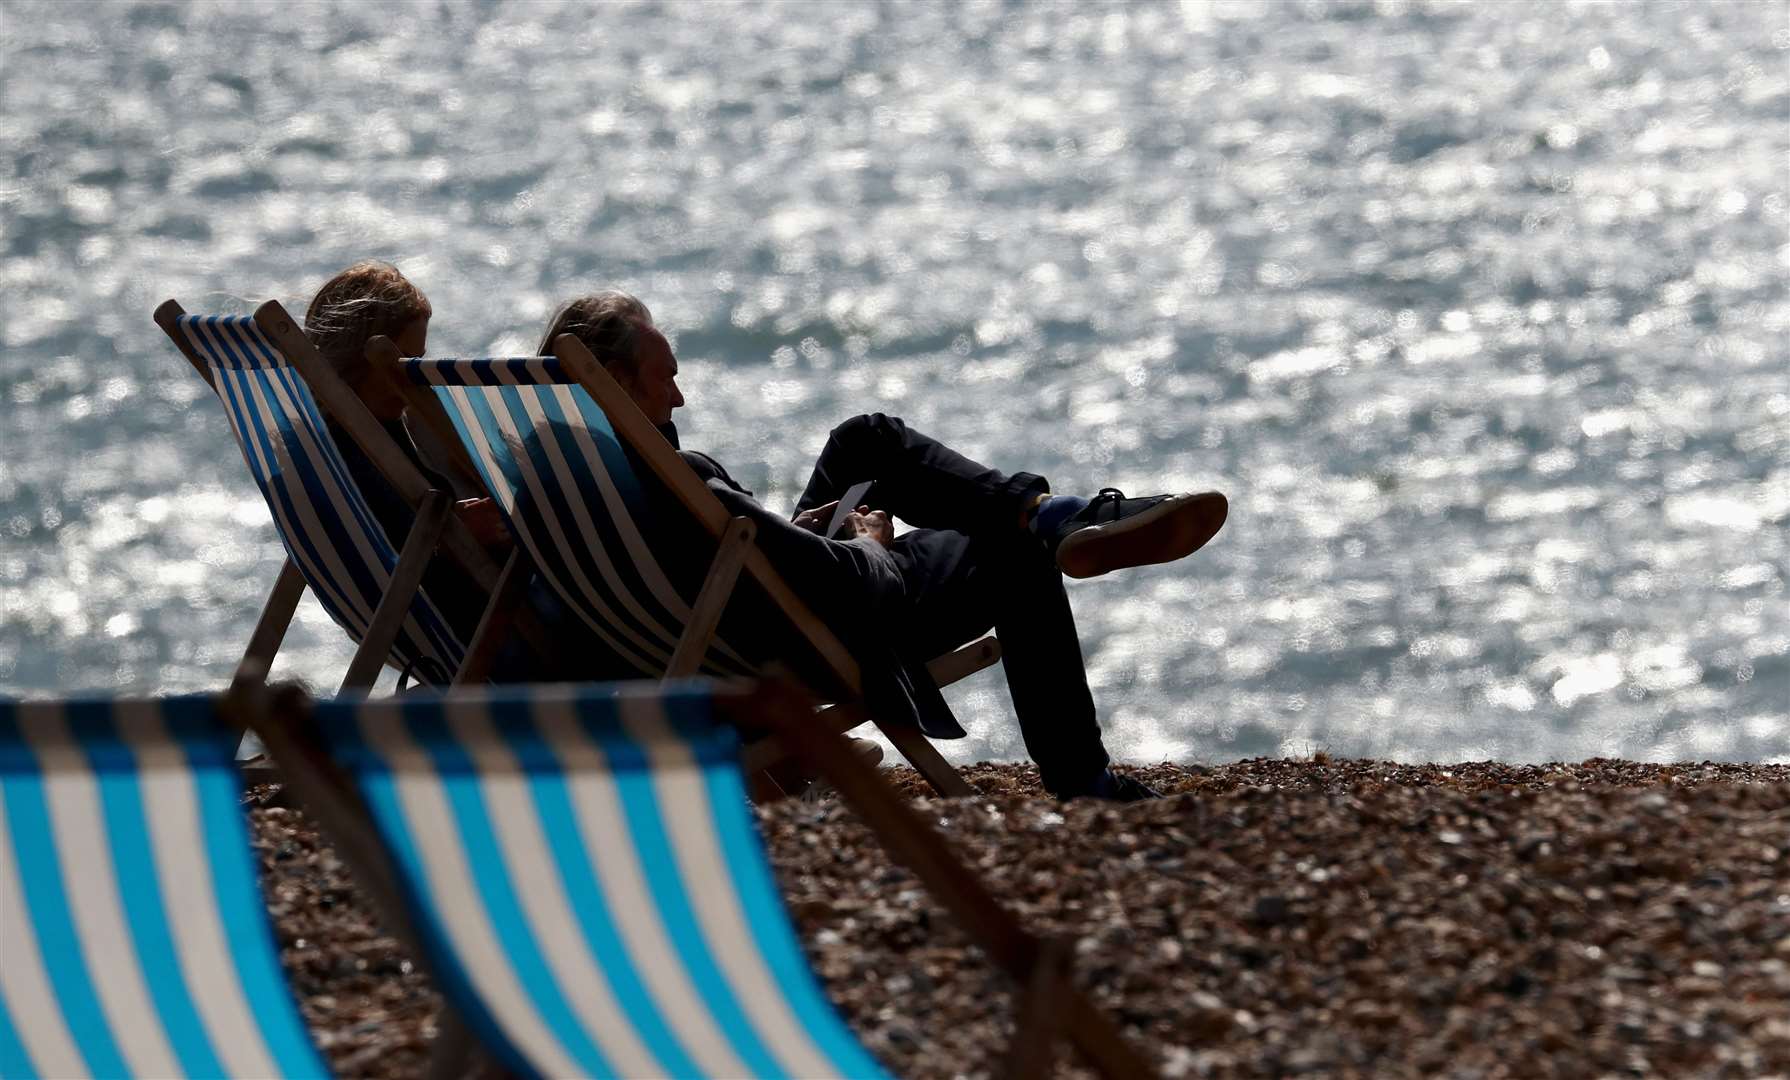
(249, 754), (1790, 1080)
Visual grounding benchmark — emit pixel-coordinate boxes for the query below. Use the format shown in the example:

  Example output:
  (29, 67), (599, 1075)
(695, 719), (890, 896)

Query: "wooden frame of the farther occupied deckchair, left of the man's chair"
(156, 299), (546, 691)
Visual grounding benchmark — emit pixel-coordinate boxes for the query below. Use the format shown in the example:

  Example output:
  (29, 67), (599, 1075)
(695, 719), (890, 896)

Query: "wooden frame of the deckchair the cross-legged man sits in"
(381, 333), (1001, 795)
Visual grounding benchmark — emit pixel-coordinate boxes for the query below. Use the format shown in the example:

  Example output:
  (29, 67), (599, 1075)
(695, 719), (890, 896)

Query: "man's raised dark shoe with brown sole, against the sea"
(1054, 487), (1230, 577)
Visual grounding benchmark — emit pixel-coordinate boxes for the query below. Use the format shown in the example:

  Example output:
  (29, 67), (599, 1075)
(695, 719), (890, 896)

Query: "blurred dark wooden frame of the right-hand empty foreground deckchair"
(229, 672), (1156, 1080)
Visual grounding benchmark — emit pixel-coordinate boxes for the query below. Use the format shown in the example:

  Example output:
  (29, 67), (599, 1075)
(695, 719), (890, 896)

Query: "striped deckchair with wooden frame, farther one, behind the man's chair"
(156, 301), (529, 690)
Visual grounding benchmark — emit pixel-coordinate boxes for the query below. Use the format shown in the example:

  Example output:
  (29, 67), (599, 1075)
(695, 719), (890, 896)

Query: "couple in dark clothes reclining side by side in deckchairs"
(304, 261), (1226, 801)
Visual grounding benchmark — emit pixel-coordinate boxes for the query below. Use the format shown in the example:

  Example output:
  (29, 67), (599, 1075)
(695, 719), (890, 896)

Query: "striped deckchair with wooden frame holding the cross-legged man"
(392, 335), (999, 795)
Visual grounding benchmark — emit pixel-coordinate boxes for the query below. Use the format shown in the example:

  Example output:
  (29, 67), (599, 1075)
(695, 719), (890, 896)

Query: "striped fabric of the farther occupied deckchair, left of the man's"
(179, 315), (465, 686)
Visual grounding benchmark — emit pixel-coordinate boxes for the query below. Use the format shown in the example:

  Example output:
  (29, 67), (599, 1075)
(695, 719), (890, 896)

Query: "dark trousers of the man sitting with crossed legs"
(794, 414), (1108, 793)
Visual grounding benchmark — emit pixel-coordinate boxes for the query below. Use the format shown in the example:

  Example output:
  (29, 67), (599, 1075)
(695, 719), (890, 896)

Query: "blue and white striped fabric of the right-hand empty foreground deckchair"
(317, 684), (884, 1076)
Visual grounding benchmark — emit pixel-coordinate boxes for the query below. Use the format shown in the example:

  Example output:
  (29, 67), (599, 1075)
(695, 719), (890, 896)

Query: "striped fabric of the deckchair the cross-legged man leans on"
(403, 356), (752, 677)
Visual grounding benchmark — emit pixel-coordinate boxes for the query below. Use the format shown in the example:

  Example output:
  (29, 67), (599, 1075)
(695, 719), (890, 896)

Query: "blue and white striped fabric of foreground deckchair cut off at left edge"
(0, 697), (328, 1078)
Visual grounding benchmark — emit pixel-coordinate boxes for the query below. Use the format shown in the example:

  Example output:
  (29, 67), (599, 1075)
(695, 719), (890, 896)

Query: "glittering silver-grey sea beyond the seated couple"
(0, 0), (1790, 763)
